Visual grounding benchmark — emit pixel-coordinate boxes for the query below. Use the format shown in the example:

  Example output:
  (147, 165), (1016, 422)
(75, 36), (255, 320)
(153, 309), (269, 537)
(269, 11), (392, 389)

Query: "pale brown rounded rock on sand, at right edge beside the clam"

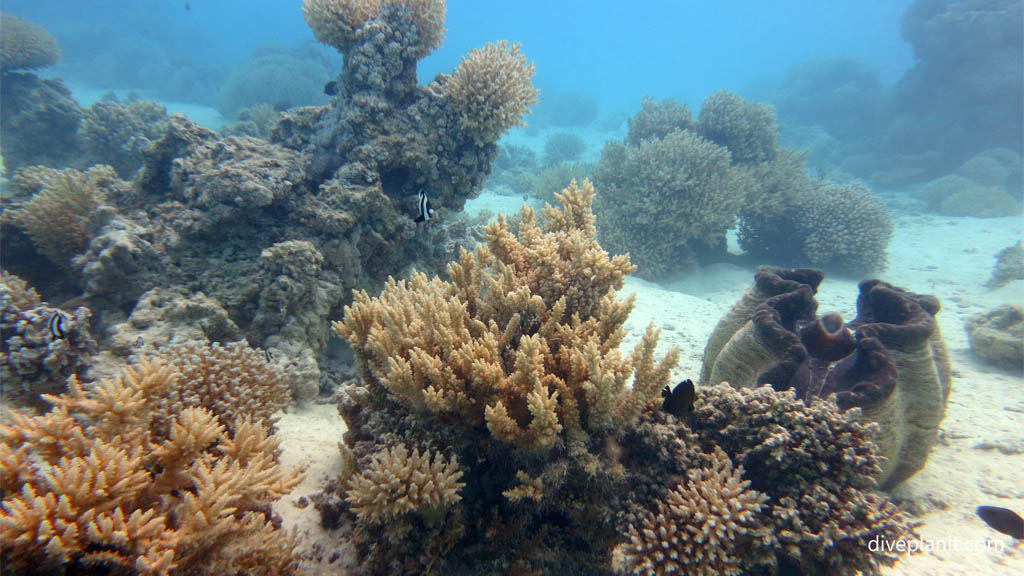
(965, 305), (1024, 374)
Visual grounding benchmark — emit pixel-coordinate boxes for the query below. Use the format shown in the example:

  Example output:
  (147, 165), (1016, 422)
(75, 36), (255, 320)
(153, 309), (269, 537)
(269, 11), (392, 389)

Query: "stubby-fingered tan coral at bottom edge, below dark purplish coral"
(612, 449), (770, 576)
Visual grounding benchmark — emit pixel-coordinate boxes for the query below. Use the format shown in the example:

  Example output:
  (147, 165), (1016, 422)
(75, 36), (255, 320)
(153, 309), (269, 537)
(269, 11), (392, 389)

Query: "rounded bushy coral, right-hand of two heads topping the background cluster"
(697, 90), (778, 164)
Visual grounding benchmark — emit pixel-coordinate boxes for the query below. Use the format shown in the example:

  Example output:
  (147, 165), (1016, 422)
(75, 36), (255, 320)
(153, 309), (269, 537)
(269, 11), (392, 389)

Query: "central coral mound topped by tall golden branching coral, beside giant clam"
(314, 182), (909, 576)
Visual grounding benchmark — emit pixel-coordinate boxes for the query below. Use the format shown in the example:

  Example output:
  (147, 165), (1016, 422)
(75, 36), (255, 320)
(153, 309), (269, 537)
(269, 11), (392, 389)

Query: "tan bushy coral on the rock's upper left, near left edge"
(11, 166), (120, 266)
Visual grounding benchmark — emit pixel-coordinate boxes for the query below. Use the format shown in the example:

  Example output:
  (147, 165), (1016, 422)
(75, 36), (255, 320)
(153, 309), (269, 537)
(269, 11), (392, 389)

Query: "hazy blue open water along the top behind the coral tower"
(3, 0), (913, 114)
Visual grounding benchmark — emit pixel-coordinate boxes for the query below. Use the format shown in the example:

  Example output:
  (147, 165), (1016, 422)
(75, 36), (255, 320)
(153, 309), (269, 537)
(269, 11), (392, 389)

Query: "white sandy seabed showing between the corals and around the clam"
(276, 198), (1024, 576)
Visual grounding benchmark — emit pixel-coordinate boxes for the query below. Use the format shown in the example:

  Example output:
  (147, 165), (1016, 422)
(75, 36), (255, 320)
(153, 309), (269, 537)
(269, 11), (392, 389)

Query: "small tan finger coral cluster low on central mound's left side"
(345, 445), (465, 524)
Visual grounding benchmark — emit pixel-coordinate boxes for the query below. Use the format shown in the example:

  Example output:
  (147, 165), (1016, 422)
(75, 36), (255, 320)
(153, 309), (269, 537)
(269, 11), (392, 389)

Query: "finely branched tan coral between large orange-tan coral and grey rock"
(154, 341), (292, 424)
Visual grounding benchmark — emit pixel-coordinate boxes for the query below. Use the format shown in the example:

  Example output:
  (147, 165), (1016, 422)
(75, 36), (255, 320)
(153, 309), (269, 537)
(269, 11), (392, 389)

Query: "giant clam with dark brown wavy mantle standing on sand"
(701, 266), (952, 488)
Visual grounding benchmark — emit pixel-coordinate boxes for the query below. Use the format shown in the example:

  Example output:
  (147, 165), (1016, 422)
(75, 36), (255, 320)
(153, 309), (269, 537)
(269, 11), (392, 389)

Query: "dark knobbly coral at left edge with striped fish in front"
(0, 271), (96, 405)
